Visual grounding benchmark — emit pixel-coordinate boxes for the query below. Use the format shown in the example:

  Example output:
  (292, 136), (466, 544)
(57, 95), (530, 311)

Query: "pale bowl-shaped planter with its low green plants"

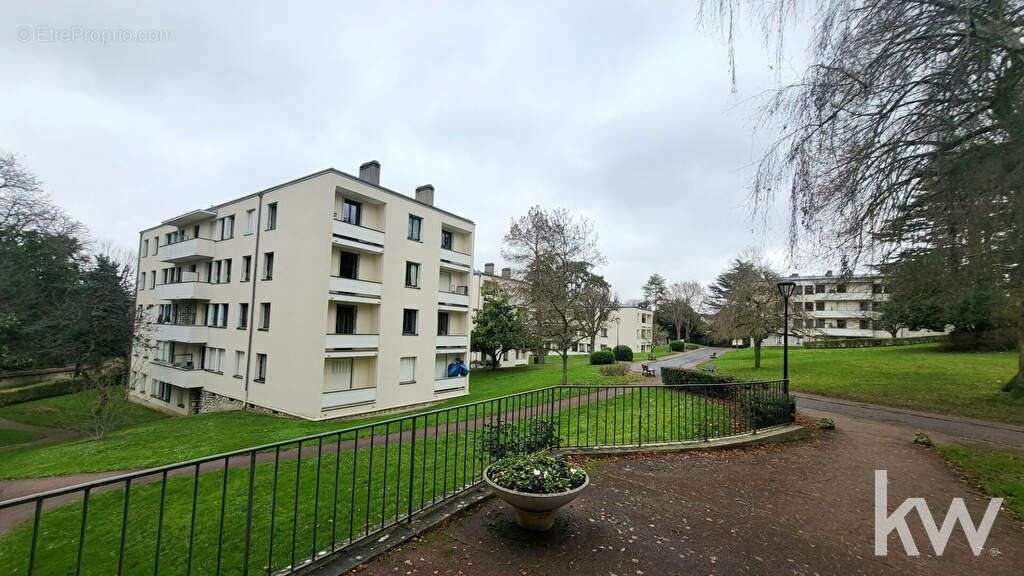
(483, 454), (590, 532)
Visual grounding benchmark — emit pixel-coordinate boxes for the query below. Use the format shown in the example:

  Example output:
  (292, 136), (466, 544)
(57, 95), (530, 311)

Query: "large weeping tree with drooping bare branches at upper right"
(701, 0), (1024, 389)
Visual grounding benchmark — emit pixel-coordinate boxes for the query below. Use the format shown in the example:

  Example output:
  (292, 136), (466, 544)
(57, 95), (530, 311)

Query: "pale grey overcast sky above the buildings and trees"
(0, 1), (821, 298)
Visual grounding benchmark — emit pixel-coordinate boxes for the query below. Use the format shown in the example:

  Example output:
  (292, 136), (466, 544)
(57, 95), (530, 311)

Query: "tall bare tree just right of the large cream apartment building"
(502, 206), (604, 384)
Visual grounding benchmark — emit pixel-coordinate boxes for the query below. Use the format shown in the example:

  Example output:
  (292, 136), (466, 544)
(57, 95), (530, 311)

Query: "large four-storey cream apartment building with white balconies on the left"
(131, 162), (474, 419)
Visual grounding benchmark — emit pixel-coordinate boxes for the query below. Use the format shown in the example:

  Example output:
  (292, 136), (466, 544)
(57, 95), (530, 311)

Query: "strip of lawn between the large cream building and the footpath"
(0, 356), (634, 480)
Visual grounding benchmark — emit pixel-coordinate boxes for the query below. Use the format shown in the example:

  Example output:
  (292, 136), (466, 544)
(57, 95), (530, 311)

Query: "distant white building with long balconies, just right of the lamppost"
(765, 271), (941, 345)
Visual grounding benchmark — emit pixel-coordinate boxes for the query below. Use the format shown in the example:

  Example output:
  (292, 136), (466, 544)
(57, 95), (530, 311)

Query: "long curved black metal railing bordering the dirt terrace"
(0, 380), (793, 576)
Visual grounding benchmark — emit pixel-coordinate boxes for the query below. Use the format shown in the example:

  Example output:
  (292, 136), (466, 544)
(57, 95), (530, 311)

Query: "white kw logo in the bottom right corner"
(874, 470), (1002, 556)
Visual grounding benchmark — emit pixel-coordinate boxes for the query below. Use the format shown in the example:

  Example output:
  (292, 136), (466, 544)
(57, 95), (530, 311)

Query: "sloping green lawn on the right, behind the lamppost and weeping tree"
(705, 344), (1024, 424)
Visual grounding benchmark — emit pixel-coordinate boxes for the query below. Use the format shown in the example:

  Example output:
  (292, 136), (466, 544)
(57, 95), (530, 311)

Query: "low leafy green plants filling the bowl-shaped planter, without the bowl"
(488, 454), (587, 494)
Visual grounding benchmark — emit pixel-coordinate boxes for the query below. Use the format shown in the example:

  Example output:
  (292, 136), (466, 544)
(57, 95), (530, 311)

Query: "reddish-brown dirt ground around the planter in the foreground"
(354, 416), (1024, 576)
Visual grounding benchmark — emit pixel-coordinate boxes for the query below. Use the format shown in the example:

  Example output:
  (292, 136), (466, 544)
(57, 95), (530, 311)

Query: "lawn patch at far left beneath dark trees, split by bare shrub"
(0, 389), (167, 429)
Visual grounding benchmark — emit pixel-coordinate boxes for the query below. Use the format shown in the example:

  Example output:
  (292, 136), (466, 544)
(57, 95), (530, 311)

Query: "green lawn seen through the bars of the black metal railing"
(0, 381), (716, 575)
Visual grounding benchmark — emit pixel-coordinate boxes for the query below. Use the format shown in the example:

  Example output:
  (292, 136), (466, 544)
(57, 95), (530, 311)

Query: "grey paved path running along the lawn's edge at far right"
(794, 393), (1024, 450)
